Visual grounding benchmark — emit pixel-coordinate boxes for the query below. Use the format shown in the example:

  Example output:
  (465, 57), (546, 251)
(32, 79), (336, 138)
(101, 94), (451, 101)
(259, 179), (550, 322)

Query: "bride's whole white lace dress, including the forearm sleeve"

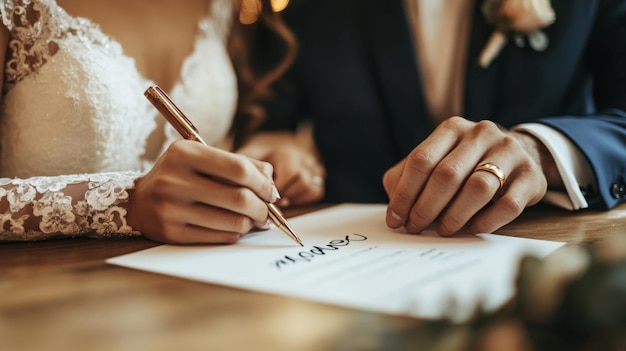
(0, 0), (237, 241)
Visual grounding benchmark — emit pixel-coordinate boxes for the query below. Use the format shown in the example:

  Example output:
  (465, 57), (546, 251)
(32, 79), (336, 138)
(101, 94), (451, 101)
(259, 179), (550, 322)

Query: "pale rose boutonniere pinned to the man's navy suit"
(478, 0), (556, 68)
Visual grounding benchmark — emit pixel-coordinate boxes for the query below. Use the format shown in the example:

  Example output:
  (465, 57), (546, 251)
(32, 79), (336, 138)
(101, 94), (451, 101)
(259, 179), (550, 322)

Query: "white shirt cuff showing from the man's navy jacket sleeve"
(513, 123), (595, 210)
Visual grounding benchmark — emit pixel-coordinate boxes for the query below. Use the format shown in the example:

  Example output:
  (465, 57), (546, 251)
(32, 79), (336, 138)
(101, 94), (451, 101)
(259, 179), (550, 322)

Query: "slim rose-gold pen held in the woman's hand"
(144, 85), (304, 246)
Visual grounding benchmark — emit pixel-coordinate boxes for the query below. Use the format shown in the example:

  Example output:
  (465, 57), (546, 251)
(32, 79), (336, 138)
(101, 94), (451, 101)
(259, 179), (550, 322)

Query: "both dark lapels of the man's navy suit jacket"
(353, 0), (508, 156)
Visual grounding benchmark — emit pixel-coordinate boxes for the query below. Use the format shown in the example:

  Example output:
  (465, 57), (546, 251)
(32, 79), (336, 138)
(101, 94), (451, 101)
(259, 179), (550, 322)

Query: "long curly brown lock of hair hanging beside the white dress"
(228, 0), (297, 149)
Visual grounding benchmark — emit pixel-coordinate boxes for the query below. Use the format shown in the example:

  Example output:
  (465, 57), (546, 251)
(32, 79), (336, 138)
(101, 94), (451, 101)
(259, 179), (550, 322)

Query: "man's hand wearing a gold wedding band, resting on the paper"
(383, 117), (562, 236)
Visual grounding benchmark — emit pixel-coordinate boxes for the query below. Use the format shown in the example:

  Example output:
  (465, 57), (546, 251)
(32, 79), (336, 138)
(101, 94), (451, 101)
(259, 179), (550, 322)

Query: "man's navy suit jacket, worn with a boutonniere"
(265, 0), (626, 209)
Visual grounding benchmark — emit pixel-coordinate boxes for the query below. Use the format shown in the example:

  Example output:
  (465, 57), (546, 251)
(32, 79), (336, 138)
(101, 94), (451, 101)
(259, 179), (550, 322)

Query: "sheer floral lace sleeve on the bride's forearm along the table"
(0, 172), (142, 241)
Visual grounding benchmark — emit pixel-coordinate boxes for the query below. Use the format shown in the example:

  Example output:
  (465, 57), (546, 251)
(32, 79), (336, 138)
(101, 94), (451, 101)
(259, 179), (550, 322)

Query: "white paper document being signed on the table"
(107, 204), (563, 321)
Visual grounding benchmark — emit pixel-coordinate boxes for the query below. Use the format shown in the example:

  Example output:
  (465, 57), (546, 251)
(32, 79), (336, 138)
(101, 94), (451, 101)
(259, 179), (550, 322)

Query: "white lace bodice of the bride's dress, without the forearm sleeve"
(0, 0), (236, 177)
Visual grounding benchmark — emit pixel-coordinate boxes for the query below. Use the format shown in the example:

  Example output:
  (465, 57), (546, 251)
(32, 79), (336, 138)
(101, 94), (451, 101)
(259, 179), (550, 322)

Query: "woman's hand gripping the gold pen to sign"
(127, 140), (278, 243)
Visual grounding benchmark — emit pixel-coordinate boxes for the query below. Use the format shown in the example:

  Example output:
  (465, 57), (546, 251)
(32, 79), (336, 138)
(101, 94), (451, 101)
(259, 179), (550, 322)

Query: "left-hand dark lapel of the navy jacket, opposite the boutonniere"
(353, 0), (430, 156)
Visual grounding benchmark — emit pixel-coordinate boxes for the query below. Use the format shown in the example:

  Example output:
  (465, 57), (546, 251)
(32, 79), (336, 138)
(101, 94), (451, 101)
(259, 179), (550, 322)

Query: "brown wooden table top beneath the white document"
(0, 205), (626, 351)
